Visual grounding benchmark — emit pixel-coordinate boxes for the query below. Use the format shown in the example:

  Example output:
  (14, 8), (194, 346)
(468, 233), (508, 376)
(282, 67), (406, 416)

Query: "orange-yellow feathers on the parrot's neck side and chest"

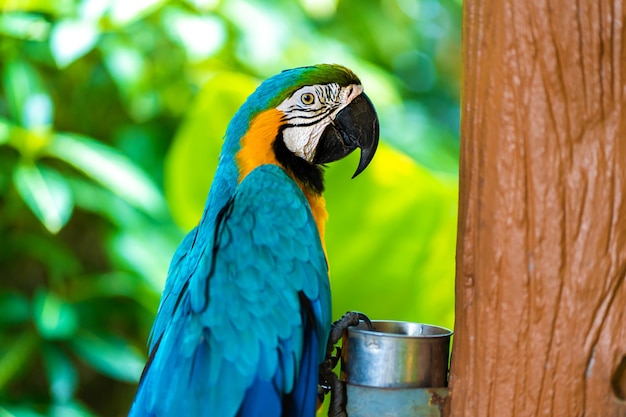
(235, 109), (328, 252)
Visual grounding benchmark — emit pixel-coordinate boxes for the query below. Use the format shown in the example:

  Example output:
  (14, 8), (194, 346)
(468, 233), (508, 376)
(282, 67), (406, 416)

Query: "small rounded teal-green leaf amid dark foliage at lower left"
(33, 291), (78, 339)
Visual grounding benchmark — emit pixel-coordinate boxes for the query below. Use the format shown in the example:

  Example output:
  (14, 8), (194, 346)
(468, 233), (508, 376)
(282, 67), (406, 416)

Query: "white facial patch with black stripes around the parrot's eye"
(277, 83), (363, 162)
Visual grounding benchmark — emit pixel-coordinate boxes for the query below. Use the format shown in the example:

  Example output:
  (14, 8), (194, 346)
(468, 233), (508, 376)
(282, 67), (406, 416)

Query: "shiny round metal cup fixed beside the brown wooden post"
(341, 321), (452, 388)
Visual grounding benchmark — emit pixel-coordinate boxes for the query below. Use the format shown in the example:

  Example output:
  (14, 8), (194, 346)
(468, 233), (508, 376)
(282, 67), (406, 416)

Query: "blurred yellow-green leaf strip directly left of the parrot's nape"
(164, 72), (258, 229)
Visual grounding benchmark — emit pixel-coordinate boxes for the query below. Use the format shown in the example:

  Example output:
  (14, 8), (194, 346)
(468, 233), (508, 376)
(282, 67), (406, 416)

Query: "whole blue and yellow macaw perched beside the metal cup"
(130, 64), (379, 417)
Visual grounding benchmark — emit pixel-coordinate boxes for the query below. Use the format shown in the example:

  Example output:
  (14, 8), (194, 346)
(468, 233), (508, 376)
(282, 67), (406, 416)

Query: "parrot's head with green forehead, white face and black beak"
(227, 64), (379, 193)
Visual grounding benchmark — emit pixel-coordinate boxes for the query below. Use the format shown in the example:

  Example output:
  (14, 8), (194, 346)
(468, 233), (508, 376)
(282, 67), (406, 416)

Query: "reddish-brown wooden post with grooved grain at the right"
(449, 0), (626, 417)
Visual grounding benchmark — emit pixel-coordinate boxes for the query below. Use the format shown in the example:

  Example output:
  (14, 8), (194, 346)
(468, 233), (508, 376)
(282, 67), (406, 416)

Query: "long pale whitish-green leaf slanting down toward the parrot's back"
(47, 133), (166, 217)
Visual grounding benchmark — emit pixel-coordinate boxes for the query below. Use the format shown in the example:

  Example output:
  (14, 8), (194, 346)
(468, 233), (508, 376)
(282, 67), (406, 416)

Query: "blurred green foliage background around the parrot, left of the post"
(0, 0), (461, 417)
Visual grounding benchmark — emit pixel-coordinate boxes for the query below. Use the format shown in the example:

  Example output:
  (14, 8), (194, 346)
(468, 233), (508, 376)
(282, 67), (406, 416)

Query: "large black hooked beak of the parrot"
(313, 93), (380, 178)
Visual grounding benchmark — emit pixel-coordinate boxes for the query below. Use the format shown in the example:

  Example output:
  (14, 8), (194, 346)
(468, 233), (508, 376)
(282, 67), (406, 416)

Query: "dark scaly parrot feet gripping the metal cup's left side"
(318, 311), (372, 417)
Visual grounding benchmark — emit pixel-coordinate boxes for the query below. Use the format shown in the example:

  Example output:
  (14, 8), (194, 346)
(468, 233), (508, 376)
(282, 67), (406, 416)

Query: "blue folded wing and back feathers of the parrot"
(130, 165), (331, 417)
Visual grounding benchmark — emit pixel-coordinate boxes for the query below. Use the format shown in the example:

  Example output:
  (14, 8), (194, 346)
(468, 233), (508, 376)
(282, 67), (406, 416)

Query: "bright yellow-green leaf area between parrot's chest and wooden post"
(325, 142), (457, 327)
